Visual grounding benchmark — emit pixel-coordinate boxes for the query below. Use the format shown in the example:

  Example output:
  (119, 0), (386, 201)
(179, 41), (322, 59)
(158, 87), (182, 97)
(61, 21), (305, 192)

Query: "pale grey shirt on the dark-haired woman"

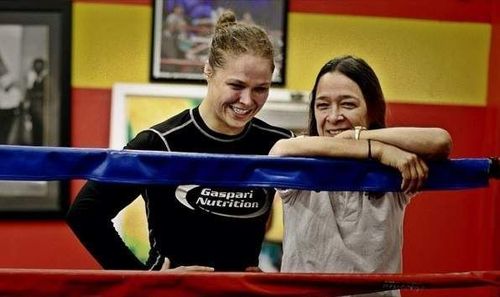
(278, 190), (410, 296)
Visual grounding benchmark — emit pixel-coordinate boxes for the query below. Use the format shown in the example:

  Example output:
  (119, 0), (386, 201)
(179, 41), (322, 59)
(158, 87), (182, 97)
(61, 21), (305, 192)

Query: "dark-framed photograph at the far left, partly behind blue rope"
(0, 0), (71, 219)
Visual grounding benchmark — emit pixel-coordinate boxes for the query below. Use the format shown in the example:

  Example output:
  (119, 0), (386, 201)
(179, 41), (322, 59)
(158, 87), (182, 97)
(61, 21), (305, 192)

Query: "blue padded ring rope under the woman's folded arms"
(0, 145), (490, 191)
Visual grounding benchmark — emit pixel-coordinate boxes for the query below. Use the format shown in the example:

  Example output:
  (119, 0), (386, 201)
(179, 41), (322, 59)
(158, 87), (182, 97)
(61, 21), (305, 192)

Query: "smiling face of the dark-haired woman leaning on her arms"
(314, 71), (368, 136)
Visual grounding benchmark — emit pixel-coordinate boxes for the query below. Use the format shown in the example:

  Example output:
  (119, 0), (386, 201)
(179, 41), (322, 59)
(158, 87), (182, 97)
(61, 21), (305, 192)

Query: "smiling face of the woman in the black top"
(200, 54), (272, 135)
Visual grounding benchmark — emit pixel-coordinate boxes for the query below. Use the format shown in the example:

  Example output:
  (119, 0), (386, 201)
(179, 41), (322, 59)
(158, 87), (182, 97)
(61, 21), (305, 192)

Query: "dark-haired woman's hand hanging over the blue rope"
(372, 141), (429, 194)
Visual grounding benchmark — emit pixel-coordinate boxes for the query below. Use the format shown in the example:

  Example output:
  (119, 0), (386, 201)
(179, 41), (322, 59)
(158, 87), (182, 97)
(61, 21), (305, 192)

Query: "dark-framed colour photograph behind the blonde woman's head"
(151, 0), (287, 85)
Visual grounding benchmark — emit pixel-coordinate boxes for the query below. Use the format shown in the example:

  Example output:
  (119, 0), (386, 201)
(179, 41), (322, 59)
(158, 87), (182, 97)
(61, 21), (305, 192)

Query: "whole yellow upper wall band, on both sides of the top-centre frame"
(72, 3), (491, 106)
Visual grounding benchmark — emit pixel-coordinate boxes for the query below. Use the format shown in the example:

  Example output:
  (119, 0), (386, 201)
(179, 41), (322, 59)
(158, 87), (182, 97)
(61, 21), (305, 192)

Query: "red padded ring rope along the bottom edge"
(0, 269), (500, 297)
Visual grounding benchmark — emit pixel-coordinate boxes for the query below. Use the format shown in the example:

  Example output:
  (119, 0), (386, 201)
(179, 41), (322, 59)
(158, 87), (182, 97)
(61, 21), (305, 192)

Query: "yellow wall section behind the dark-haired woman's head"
(287, 13), (491, 105)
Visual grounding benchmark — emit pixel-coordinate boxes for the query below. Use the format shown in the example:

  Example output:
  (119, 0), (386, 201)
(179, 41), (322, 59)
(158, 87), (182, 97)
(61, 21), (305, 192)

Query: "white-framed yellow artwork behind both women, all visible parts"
(109, 83), (308, 262)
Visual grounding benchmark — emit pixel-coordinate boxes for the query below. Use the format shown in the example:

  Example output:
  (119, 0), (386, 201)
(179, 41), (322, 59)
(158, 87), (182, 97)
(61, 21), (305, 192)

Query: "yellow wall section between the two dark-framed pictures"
(72, 3), (151, 88)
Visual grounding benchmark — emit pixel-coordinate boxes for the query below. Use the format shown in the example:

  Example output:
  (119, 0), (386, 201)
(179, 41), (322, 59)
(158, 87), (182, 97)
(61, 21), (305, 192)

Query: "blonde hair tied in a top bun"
(208, 10), (274, 71)
